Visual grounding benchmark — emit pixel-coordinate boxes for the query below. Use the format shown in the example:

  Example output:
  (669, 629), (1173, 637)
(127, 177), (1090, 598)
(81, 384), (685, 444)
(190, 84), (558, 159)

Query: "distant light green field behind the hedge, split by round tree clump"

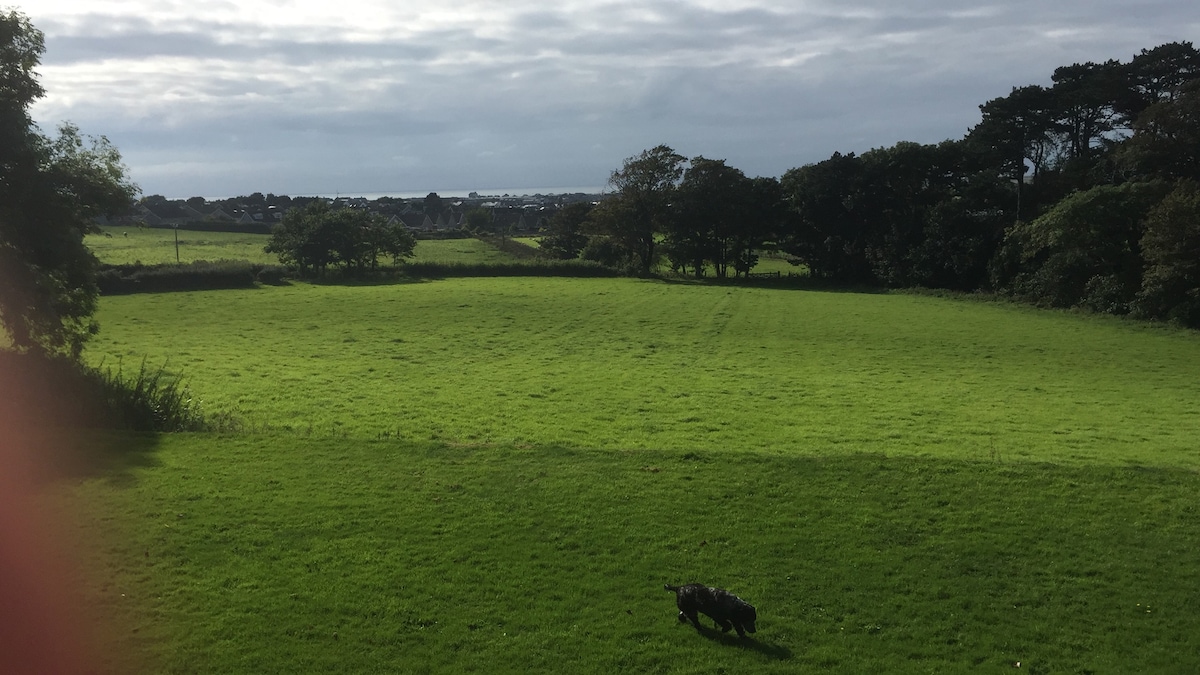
(85, 227), (512, 264)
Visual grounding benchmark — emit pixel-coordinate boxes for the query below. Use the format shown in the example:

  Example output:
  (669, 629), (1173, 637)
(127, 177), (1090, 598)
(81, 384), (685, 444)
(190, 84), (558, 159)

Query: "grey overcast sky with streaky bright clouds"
(17, 0), (1200, 197)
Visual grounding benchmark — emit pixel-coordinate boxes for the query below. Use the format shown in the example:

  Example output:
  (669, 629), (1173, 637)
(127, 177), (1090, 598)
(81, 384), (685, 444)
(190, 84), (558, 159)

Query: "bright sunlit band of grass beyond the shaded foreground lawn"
(89, 279), (1200, 467)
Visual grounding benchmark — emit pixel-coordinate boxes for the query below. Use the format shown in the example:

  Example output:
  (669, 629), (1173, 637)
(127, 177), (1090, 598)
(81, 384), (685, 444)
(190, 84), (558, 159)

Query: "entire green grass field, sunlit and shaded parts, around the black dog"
(44, 277), (1200, 673)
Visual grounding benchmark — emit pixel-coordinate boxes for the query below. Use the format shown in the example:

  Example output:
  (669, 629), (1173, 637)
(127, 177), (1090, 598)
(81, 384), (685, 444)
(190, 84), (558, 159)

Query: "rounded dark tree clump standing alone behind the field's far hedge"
(264, 201), (416, 275)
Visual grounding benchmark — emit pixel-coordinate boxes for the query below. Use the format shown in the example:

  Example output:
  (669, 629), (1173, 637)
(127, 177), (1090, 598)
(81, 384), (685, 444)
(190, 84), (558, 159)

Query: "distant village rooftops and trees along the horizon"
(101, 192), (602, 237)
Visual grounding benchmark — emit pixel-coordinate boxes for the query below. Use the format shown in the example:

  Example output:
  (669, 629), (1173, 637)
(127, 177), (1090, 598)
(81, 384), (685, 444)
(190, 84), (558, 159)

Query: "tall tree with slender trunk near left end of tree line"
(592, 145), (686, 275)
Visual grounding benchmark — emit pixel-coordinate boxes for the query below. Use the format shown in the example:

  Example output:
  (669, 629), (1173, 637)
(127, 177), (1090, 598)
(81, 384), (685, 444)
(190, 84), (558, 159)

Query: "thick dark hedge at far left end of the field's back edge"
(96, 261), (284, 295)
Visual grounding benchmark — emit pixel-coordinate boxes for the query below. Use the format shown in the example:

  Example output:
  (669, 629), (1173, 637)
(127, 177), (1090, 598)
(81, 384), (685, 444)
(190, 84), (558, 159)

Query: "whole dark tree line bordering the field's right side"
(554, 42), (1200, 327)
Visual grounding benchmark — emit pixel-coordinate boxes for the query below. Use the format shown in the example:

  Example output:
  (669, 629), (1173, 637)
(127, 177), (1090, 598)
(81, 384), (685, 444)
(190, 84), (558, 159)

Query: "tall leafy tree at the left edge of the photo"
(0, 11), (137, 357)
